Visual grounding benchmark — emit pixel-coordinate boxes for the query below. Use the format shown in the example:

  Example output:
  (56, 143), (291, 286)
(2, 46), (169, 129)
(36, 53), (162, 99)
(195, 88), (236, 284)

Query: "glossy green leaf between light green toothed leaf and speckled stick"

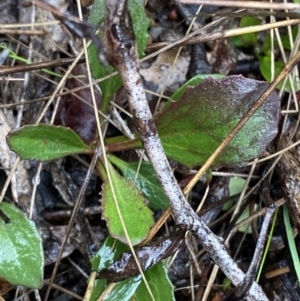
(108, 155), (170, 209)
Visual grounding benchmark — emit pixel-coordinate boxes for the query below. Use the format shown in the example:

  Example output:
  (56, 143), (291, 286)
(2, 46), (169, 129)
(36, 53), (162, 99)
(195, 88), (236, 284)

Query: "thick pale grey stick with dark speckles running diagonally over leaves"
(104, 0), (268, 301)
